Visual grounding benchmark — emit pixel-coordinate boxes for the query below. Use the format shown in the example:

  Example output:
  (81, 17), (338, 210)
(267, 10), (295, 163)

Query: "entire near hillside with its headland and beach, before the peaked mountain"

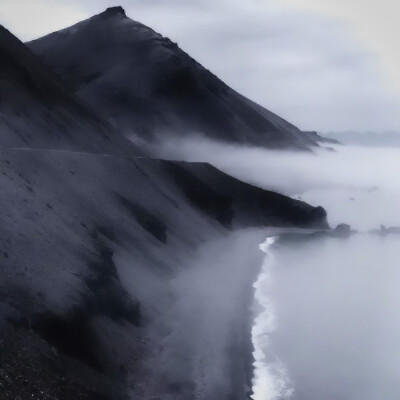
(0, 16), (327, 400)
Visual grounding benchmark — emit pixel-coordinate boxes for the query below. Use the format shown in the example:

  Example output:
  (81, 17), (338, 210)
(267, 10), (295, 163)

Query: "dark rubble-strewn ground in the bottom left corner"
(0, 320), (112, 400)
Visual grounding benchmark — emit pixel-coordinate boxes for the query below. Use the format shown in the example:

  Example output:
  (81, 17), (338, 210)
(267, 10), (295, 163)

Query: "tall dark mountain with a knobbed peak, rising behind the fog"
(28, 7), (316, 148)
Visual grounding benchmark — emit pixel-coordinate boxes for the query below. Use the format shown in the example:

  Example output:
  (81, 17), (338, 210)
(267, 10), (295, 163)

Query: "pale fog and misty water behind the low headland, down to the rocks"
(156, 138), (400, 231)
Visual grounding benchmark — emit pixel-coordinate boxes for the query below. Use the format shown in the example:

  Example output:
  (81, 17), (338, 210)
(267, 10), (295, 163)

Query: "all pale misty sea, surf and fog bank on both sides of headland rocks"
(157, 140), (400, 400)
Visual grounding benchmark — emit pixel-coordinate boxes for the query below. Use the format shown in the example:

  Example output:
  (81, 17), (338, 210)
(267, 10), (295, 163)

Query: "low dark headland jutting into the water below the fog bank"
(166, 162), (329, 229)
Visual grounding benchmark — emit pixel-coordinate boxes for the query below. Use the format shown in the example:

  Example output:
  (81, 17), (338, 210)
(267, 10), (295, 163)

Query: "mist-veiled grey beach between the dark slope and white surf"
(118, 229), (265, 400)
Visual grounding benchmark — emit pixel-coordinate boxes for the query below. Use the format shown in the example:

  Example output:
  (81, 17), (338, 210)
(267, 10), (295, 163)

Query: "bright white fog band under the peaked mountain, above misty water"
(155, 138), (400, 194)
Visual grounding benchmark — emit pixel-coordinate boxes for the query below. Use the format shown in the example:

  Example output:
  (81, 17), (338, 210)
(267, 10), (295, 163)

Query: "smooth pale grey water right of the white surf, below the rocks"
(266, 236), (400, 400)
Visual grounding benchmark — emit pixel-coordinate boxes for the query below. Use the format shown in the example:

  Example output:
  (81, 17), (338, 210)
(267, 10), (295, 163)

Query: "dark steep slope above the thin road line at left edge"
(0, 26), (133, 154)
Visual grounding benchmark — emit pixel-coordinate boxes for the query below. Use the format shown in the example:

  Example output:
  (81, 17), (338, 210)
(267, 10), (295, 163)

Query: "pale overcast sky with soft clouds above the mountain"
(0, 0), (400, 132)
